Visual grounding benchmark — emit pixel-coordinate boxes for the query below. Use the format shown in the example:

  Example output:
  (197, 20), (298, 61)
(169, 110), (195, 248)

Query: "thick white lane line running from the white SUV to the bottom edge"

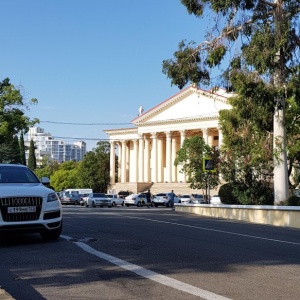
(60, 235), (231, 300)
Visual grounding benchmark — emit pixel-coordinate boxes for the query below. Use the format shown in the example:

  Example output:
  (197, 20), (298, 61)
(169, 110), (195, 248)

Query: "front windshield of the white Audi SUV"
(0, 165), (40, 183)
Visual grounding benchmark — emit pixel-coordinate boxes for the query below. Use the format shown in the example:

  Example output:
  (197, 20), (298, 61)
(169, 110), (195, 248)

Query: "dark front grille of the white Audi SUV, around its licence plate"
(0, 197), (43, 222)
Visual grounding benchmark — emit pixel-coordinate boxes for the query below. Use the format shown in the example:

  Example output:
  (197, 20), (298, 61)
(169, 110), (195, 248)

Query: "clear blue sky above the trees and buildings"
(0, 0), (213, 150)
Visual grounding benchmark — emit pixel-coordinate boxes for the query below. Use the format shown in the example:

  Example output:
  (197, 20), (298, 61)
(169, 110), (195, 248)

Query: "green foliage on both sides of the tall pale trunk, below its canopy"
(219, 71), (300, 204)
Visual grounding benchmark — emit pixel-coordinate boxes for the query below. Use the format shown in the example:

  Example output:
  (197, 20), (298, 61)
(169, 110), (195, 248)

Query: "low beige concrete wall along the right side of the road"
(175, 203), (300, 228)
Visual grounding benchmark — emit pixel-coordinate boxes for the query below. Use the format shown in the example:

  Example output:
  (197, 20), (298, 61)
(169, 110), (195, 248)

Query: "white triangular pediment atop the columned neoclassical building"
(132, 86), (232, 127)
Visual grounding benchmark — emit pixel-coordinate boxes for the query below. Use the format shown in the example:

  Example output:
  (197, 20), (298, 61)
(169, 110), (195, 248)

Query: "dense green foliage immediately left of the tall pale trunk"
(219, 72), (273, 195)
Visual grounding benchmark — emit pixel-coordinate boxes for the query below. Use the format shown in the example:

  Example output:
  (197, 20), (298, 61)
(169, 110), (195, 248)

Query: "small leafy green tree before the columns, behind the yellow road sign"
(174, 136), (219, 190)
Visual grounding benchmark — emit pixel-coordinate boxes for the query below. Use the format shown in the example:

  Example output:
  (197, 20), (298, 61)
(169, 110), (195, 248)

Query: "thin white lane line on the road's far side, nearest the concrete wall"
(123, 216), (300, 246)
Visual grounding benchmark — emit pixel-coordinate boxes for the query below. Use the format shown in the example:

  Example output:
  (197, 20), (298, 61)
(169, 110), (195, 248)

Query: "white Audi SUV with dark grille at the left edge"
(0, 164), (62, 240)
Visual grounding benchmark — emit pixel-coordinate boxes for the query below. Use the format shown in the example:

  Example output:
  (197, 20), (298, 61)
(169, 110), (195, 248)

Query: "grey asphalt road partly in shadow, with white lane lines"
(0, 206), (300, 300)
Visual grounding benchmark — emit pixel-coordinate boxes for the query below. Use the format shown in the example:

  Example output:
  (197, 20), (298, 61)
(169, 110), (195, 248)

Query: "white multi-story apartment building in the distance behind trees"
(25, 127), (86, 165)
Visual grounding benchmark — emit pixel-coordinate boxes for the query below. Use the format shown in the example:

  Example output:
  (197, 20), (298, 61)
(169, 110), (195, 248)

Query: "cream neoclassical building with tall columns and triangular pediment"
(104, 86), (231, 191)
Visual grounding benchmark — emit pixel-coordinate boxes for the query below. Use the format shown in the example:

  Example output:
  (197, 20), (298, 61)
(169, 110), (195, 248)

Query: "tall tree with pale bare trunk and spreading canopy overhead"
(163, 0), (300, 203)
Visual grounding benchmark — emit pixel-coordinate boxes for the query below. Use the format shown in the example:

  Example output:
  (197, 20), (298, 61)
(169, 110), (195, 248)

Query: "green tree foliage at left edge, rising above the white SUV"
(0, 78), (38, 162)
